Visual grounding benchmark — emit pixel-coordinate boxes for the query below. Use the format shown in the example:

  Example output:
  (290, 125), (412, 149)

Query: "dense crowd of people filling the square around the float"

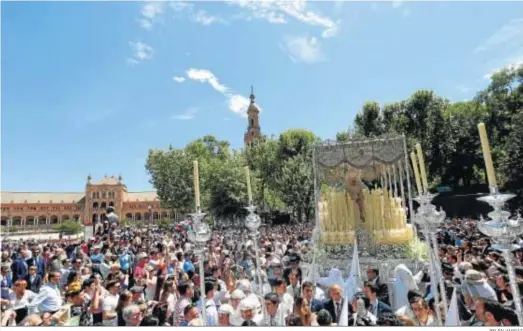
(0, 209), (523, 326)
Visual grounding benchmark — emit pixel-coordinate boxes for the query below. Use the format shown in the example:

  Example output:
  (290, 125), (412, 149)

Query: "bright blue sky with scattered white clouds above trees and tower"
(1, 0), (523, 191)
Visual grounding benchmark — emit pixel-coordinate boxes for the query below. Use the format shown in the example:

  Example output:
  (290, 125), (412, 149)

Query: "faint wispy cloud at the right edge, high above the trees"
(473, 18), (523, 53)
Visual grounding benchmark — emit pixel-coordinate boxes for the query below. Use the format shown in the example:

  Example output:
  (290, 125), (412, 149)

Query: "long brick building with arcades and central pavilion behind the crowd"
(1, 176), (183, 227)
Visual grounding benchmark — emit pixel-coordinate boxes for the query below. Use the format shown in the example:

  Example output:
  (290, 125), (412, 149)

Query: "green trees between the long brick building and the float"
(146, 130), (318, 221)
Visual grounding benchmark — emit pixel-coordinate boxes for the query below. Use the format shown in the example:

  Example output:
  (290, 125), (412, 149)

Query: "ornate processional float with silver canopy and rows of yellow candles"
(309, 135), (420, 279)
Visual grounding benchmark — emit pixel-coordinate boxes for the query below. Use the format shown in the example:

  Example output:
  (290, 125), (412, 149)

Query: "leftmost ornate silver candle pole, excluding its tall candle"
(187, 208), (212, 326)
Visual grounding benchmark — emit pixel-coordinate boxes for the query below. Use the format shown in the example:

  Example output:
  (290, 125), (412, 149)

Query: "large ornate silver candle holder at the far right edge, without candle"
(478, 187), (523, 325)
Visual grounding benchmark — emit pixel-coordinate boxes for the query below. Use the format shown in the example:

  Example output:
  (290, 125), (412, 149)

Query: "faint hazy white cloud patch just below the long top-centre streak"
(280, 36), (325, 63)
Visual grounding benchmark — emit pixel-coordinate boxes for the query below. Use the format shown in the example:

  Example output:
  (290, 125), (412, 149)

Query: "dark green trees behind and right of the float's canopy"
(336, 66), (523, 205)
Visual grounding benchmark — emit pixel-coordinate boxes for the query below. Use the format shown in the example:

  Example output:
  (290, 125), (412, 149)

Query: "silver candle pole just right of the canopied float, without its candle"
(414, 191), (448, 326)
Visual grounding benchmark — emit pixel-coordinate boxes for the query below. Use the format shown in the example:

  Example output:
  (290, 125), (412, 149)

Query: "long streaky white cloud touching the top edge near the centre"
(229, 0), (340, 38)
